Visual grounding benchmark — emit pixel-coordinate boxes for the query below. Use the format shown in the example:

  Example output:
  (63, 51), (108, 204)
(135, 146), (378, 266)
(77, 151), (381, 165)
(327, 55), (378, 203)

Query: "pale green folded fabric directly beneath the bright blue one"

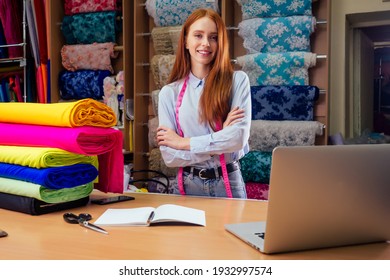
(0, 177), (93, 203)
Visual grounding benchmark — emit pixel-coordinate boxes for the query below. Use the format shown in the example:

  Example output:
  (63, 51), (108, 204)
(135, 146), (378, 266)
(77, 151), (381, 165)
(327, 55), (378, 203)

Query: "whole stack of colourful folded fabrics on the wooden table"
(0, 99), (123, 215)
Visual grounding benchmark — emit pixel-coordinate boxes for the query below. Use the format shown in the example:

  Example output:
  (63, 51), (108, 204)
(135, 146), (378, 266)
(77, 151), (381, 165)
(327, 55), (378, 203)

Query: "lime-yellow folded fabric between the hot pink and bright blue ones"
(0, 146), (98, 168)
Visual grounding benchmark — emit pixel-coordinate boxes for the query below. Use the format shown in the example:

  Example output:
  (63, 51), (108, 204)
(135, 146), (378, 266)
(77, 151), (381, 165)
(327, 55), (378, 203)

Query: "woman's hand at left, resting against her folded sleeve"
(157, 126), (190, 150)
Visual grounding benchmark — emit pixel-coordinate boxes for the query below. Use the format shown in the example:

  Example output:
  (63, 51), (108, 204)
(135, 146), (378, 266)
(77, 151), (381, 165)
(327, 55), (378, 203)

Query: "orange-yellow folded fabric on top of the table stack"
(0, 98), (117, 127)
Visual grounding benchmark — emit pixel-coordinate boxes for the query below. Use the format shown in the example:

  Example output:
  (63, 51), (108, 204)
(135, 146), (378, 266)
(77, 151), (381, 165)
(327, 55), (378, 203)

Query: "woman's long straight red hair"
(168, 9), (233, 130)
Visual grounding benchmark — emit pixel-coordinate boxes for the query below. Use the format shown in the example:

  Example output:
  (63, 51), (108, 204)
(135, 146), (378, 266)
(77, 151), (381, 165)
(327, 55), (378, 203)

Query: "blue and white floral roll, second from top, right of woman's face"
(238, 16), (315, 53)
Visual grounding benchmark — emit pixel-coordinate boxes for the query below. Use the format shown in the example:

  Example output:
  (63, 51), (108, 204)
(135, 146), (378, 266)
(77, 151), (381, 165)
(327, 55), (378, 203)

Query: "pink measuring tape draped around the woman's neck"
(175, 77), (233, 198)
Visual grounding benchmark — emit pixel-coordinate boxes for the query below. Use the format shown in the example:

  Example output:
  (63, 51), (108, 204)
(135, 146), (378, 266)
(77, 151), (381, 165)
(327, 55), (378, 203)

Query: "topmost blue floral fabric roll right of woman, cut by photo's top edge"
(237, 0), (312, 20)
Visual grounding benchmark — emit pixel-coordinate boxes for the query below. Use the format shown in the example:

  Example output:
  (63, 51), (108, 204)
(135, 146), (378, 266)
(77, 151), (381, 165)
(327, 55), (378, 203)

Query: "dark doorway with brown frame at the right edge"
(346, 11), (390, 140)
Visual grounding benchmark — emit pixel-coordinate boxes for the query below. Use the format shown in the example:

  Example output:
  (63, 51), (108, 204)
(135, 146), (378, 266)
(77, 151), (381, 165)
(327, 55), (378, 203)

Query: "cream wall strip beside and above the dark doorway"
(330, 0), (390, 135)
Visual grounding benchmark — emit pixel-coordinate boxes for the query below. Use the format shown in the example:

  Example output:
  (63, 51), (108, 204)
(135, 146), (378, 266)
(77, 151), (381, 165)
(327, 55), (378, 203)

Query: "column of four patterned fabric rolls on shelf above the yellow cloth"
(58, 0), (122, 104)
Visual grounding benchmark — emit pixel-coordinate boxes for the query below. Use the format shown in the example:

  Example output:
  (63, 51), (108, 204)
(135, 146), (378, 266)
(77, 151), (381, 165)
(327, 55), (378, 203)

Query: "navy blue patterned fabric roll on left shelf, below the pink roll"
(58, 70), (111, 100)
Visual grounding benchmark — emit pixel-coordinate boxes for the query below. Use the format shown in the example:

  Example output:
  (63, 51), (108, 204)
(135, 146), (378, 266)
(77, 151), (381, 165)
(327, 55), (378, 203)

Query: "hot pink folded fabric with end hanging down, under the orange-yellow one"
(0, 123), (124, 193)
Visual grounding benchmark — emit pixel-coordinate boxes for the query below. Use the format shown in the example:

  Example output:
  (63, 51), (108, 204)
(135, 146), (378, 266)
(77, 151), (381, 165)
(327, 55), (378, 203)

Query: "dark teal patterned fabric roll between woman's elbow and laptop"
(240, 150), (272, 184)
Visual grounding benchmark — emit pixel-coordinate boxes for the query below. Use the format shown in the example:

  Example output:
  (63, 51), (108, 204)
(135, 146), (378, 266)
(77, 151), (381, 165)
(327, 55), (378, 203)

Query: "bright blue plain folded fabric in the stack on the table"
(0, 162), (98, 189)
